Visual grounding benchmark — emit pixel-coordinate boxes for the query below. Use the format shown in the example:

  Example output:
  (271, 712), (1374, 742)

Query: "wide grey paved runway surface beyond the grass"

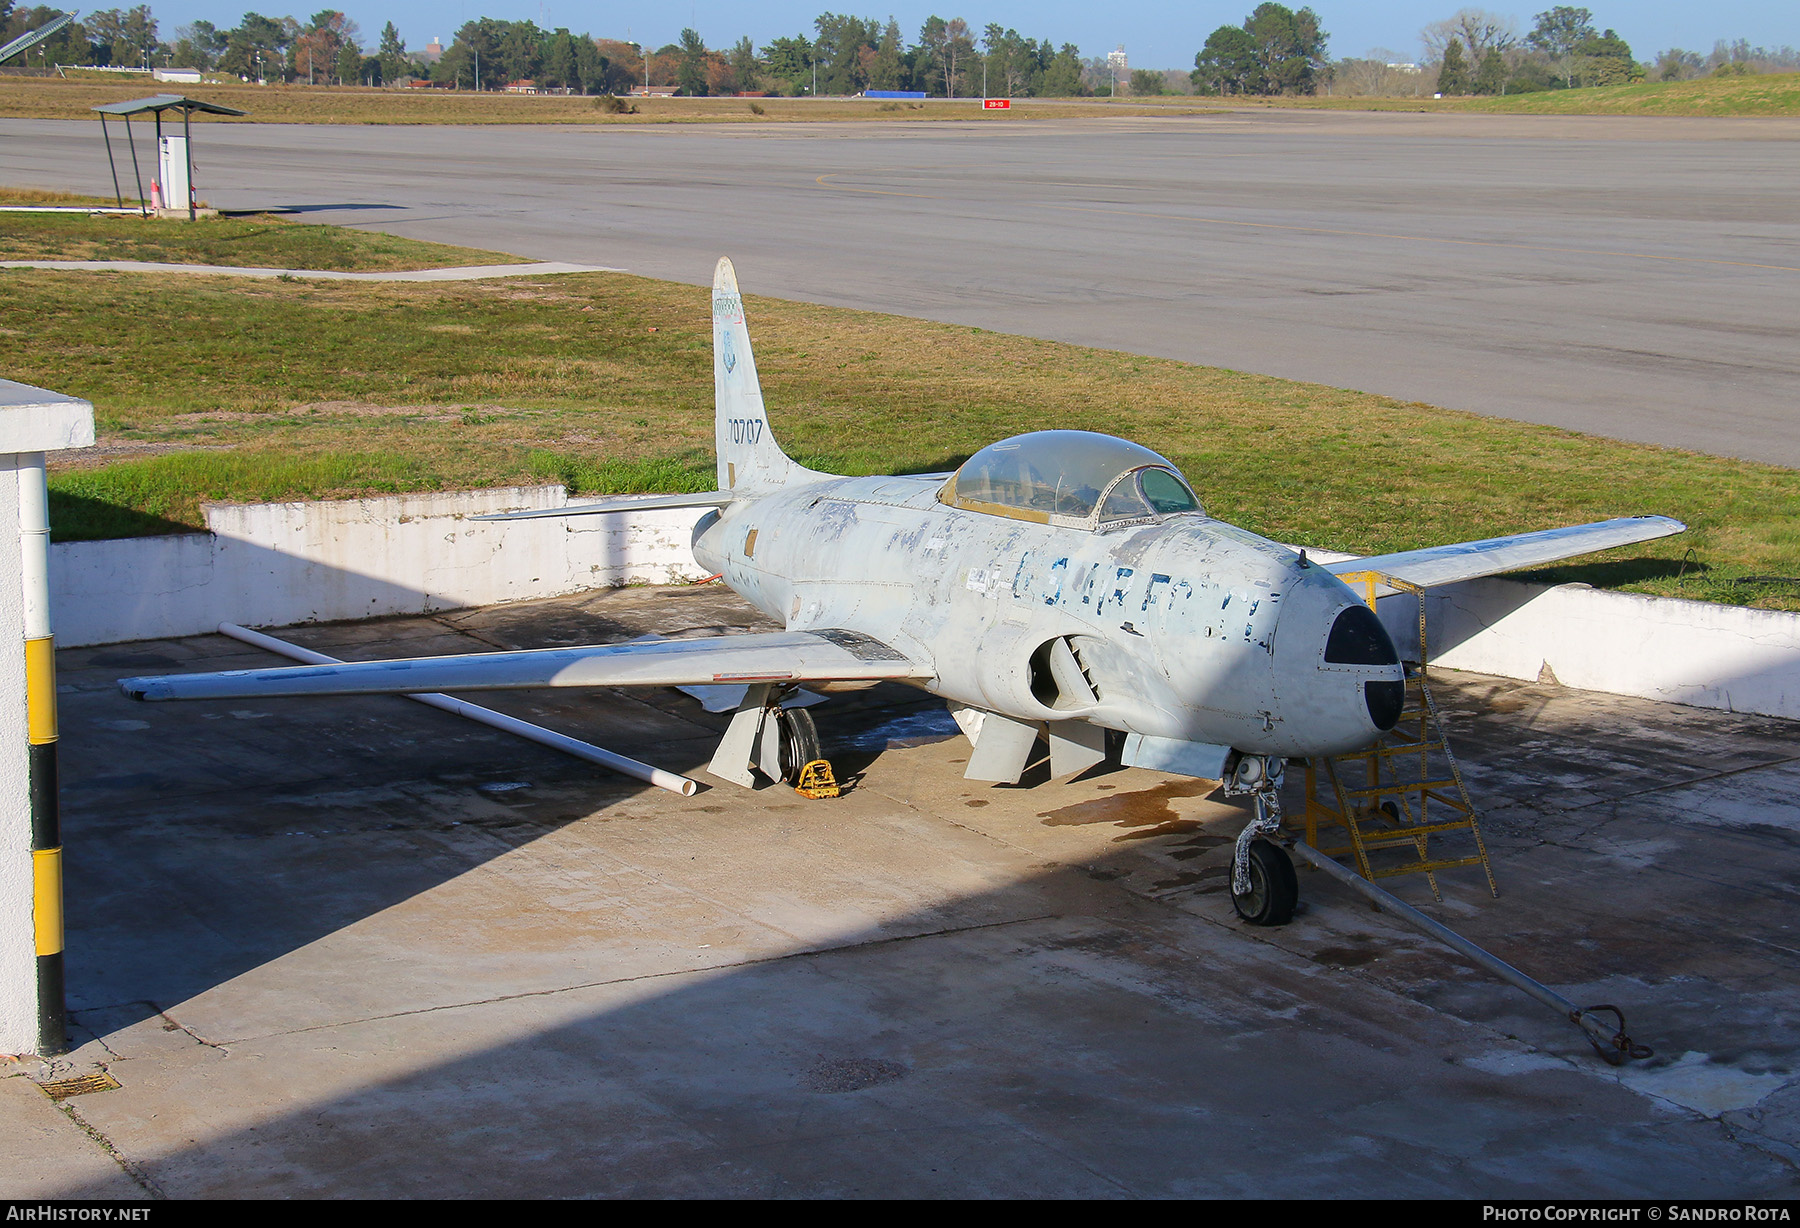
(0, 112), (1800, 466)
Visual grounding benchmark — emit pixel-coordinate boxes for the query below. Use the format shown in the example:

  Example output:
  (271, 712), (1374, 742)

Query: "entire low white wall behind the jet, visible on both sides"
(50, 486), (1800, 718)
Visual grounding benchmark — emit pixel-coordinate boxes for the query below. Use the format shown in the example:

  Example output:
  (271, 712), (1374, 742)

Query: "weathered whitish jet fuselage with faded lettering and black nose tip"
(693, 477), (1402, 756)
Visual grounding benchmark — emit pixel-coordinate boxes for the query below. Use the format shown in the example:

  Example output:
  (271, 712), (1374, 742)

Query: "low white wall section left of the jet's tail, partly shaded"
(50, 486), (702, 646)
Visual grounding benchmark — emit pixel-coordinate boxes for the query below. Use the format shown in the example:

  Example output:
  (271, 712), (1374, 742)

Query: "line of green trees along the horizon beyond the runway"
(0, 0), (1800, 97)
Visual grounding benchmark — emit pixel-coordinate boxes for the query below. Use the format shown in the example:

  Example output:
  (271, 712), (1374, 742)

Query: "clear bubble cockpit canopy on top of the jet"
(938, 430), (1201, 529)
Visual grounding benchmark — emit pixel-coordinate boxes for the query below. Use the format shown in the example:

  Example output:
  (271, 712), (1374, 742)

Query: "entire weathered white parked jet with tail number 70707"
(121, 259), (1685, 924)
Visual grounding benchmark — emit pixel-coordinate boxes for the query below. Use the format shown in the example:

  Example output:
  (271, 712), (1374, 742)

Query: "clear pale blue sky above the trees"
(158, 0), (1800, 68)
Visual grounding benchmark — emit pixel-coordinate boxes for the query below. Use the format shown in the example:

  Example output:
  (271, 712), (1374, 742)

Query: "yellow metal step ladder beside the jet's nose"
(1305, 571), (1499, 902)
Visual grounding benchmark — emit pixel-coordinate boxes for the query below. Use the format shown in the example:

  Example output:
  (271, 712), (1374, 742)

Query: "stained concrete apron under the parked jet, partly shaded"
(0, 585), (1800, 1197)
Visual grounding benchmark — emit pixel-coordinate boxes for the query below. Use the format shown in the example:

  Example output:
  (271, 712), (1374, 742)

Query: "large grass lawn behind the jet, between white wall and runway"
(0, 248), (1800, 609)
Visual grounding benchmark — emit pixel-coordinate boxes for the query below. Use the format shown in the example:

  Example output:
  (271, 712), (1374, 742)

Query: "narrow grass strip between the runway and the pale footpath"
(0, 207), (518, 272)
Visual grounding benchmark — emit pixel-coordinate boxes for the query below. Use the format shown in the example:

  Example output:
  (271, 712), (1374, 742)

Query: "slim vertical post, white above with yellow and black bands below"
(18, 452), (68, 1055)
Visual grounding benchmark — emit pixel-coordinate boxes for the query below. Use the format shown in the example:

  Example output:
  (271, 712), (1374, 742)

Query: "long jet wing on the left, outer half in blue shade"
(119, 628), (936, 700)
